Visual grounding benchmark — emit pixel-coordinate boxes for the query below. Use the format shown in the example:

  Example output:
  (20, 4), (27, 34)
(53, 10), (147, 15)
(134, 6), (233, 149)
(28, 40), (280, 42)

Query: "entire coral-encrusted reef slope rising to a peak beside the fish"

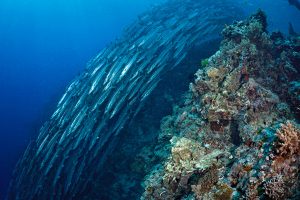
(142, 11), (300, 200)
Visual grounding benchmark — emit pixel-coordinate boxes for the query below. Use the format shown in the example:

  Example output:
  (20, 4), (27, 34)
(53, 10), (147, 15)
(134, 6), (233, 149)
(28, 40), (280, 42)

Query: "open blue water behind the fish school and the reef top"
(0, 0), (300, 199)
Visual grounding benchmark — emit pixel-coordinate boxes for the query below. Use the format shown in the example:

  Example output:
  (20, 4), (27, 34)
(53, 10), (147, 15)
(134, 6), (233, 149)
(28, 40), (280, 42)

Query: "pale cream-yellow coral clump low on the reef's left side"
(163, 138), (222, 195)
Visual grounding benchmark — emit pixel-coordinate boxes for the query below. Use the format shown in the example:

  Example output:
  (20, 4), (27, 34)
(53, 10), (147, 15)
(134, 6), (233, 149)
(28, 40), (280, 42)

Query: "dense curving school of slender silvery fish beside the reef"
(8, 0), (244, 200)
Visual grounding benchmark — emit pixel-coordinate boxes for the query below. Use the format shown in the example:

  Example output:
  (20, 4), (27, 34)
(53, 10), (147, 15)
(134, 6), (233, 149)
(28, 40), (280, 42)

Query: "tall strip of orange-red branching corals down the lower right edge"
(265, 122), (300, 199)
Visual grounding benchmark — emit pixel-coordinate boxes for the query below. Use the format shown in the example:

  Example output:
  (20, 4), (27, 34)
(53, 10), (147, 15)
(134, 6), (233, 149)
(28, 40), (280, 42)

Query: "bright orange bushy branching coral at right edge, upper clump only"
(277, 122), (300, 156)
